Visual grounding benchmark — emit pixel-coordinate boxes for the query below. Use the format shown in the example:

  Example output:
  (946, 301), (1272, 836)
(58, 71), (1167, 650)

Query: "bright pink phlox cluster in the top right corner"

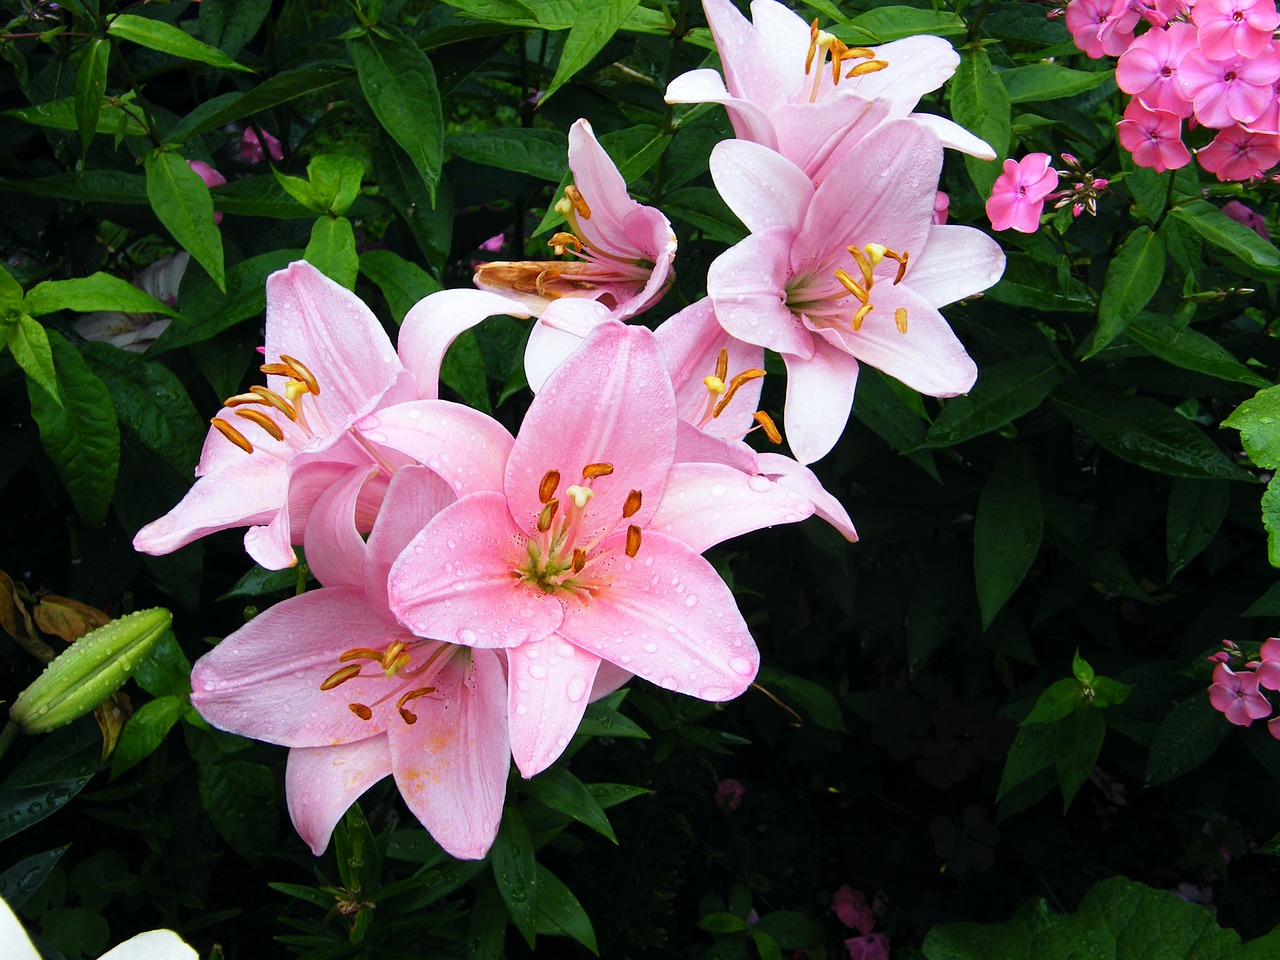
(1066, 0), (1280, 180)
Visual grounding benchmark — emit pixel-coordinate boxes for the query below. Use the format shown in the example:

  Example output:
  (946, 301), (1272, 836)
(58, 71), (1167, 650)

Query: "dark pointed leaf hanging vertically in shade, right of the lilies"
(973, 447), (1044, 630)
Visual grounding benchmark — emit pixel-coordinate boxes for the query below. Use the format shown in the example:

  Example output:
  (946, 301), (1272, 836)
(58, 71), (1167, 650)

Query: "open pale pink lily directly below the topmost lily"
(707, 120), (1005, 463)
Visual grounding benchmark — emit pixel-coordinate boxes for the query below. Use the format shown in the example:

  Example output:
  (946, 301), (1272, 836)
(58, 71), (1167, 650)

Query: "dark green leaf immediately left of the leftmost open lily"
(81, 343), (209, 477)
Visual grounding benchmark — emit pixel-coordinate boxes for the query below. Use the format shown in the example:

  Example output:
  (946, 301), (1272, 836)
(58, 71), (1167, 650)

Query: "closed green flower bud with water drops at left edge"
(9, 607), (173, 733)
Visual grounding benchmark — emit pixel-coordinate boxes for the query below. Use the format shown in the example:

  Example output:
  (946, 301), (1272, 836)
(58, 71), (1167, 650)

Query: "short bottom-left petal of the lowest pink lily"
(284, 733), (392, 856)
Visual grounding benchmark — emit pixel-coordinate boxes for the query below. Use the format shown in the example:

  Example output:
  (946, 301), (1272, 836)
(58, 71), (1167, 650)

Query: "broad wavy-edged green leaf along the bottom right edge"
(923, 877), (1249, 960)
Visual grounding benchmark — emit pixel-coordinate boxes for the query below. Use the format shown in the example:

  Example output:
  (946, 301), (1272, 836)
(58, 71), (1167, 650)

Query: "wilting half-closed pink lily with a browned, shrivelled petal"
(475, 120), (676, 320)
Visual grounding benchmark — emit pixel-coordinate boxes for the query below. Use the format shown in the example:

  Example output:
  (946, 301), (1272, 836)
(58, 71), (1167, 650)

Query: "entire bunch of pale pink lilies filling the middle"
(134, 0), (1005, 858)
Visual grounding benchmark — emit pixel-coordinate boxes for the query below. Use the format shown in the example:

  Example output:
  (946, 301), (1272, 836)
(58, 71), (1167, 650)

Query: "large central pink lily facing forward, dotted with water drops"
(360, 323), (812, 777)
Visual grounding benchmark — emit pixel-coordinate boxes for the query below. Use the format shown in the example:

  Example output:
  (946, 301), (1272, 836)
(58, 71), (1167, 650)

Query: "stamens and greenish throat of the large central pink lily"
(512, 463), (643, 595)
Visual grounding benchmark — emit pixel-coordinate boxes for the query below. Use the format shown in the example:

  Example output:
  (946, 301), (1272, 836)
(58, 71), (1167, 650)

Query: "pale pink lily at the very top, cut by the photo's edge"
(666, 0), (996, 183)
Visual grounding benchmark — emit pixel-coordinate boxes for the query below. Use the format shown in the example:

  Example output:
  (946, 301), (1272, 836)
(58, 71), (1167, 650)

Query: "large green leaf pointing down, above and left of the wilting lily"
(349, 24), (444, 204)
